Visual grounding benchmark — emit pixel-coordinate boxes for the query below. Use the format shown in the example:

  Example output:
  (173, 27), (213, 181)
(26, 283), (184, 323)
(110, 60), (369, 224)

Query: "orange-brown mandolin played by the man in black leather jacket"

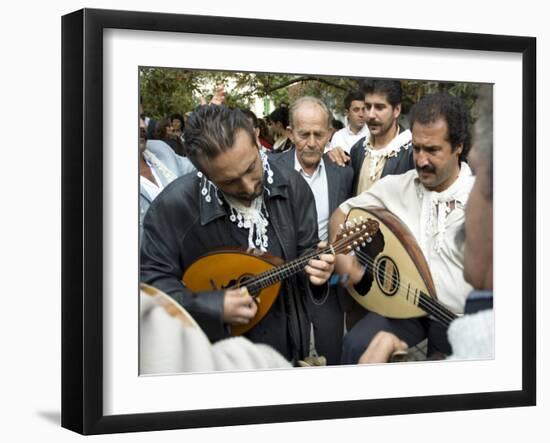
(182, 217), (378, 335)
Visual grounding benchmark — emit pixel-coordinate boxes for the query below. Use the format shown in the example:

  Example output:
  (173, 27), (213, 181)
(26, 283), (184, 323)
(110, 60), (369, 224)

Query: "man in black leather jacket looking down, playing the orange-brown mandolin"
(141, 105), (334, 363)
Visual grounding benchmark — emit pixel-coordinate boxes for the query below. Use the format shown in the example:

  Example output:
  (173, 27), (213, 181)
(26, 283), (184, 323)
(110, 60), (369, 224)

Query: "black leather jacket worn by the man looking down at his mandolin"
(141, 162), (326, 359)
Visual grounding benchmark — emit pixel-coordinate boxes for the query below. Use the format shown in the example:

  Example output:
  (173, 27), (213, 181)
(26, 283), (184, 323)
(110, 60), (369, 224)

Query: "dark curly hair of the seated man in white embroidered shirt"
(409, 92), (470, 161)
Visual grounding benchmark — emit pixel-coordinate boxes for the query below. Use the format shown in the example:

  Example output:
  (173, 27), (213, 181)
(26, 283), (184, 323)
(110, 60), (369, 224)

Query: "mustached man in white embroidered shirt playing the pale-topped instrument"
(330, 94), (474, 364)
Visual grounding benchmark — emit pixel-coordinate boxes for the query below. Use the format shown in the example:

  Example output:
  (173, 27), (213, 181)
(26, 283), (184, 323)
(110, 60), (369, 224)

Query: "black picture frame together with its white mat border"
(62, 9), (536, 434)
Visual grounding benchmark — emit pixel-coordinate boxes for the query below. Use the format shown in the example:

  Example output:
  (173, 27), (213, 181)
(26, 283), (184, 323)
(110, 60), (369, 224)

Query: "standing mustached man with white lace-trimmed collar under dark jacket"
(329, 80), (414, 195)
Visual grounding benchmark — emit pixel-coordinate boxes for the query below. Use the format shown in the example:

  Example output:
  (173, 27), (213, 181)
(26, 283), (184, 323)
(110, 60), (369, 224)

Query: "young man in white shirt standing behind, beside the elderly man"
(329, 91), (369, 154)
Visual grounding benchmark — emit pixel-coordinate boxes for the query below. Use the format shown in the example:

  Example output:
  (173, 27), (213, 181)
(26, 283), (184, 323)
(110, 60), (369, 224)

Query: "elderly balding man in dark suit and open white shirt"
(273, 96), (353, 364)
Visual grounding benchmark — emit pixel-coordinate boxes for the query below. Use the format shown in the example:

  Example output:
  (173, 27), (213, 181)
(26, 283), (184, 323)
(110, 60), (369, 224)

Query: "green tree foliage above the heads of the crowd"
(140, 67), (492, 126)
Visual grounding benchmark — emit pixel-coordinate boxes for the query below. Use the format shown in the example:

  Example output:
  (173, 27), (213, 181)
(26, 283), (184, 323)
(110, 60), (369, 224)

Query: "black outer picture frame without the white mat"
(62, 9), (537, 434)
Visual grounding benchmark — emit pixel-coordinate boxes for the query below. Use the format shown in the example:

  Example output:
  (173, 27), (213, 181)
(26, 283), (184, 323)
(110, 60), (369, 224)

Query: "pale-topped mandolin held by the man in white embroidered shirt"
(347, 207), (457, 326)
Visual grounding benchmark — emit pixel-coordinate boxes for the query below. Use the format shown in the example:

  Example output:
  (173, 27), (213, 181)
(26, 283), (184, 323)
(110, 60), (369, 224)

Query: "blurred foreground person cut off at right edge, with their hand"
(359, 96), (495, 363)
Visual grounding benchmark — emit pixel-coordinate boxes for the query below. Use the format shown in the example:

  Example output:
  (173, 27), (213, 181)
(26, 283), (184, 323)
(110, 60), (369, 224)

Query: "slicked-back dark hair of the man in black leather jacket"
(183, 105), (256, 170)
